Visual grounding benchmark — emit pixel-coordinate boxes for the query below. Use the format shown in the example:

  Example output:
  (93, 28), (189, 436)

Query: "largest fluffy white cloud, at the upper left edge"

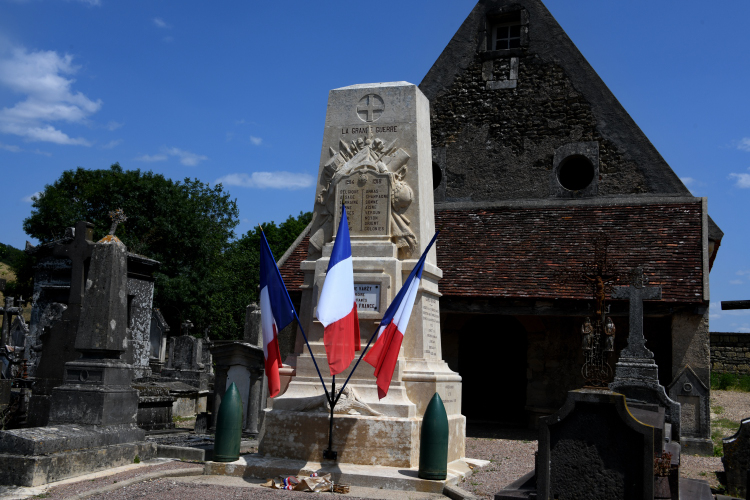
(0, 47), (102, 146)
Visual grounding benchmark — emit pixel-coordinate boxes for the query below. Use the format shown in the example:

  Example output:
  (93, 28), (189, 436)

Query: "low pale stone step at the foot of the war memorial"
(203, 453), (490, 494)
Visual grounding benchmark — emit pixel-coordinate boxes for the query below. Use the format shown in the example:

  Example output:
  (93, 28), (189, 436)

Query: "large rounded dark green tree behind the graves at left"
(23, 163), (239, 331)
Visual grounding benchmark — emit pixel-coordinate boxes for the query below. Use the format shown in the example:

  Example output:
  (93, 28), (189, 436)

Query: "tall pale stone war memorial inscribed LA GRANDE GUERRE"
(260, 82), (465, 468)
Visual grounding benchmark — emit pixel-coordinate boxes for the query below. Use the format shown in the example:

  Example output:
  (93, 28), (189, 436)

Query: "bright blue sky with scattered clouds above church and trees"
(0, 0), (750, 332)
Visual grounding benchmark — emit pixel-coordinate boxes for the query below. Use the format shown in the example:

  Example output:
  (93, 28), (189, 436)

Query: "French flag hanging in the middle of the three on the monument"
(316, 207), (360, 375)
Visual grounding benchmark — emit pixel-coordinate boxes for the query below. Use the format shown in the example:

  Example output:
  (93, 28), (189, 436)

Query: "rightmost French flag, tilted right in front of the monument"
(364, 232), (439, 399)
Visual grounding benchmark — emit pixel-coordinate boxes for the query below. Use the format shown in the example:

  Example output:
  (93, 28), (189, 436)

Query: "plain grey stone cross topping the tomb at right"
(612, 267), (661, 358)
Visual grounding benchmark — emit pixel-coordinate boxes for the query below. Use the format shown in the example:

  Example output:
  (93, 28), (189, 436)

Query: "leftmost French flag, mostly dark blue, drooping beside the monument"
(260, 230), (295, 397)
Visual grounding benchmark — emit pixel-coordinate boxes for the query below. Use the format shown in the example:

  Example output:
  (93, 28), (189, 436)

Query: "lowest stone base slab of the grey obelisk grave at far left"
(0, 441), (156, 486)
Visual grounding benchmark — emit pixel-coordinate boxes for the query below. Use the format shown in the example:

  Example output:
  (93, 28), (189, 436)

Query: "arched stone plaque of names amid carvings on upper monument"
(335, 171), (391, 236)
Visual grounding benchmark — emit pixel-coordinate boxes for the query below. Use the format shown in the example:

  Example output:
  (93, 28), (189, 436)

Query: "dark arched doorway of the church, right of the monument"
(458, 314), (527, 425)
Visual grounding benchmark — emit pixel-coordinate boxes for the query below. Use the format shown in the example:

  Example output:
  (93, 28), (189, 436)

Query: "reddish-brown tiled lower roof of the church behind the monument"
(281, 202), (703, 302)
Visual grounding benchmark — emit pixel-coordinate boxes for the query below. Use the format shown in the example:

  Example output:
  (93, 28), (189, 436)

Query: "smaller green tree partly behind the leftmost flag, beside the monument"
(211, 212), (312, 339)
